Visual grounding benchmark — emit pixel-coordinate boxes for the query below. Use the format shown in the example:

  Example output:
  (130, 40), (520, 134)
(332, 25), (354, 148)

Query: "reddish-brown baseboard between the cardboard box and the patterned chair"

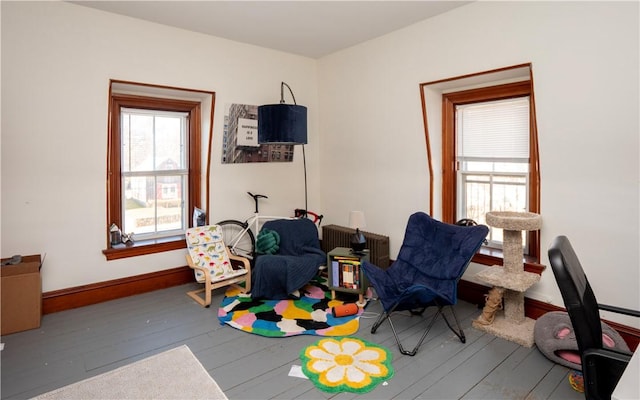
(42, 266), (195, 314)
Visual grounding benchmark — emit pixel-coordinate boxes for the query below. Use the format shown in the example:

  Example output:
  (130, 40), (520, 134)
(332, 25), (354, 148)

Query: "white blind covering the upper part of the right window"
(456, 96), (529, 162)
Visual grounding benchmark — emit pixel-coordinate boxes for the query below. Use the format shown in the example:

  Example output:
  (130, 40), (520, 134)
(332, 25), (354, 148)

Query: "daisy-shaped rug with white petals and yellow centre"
(300, 337), (393, 393)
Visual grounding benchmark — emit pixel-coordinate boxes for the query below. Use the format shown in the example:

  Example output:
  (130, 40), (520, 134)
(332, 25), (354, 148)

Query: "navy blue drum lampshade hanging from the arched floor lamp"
(258, 103), (307, 144)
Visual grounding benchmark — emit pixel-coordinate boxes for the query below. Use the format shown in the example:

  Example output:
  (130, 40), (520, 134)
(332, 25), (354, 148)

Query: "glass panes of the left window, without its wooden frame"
(120, 107), (189, 240)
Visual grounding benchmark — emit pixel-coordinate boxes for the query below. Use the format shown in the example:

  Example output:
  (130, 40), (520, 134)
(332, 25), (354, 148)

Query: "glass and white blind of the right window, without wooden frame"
(455, 96), (529, 248)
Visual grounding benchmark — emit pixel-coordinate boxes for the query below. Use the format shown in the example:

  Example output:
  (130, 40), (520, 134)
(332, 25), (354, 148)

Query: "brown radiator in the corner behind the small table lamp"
(322, 225), (389, 269)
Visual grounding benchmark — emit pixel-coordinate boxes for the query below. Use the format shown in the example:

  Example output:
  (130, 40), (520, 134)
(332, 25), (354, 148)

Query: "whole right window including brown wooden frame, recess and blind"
(421, 64), (540, 269)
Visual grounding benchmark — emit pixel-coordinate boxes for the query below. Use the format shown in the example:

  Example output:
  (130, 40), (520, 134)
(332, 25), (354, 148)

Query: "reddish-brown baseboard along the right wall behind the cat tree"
(458, 280), (640, 351)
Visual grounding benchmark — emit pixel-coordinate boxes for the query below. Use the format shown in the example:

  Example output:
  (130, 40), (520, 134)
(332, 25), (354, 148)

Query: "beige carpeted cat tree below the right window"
(473, 211), (542, 347)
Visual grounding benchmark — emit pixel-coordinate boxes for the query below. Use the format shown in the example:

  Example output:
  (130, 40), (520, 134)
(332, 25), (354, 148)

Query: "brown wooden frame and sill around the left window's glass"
(102, 94), (202, 260)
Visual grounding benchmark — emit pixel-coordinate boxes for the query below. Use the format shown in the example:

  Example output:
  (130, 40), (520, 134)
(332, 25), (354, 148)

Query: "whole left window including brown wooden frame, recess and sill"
(103, 81), (213, 260)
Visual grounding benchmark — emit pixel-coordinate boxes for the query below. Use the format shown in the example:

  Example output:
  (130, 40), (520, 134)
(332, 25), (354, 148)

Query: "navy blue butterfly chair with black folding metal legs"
(363, 212), (489, 356)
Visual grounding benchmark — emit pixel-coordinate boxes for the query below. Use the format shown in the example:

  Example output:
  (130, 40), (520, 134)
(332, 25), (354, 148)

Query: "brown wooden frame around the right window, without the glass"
(442, 80), (540, 264)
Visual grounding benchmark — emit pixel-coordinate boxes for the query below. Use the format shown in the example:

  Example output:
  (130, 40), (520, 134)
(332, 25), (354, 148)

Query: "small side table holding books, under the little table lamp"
(327, 247), (369, 307)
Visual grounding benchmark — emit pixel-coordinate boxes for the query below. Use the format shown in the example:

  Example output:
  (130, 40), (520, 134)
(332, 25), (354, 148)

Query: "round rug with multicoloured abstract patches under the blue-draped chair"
(218, 278), (364, 337)
